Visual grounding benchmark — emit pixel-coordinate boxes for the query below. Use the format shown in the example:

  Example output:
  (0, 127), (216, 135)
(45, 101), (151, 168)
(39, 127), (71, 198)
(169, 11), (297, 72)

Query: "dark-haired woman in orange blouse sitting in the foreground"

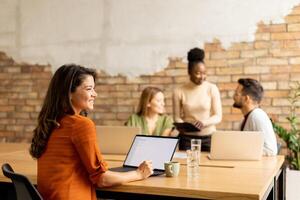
(30, 64), (153, 200)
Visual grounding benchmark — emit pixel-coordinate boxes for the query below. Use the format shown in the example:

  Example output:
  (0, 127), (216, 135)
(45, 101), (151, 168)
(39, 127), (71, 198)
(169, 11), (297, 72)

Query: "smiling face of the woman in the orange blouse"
(70, 75), (97, 114)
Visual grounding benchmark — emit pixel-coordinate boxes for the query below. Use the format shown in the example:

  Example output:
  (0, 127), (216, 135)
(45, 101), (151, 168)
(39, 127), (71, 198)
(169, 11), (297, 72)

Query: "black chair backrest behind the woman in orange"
(2, 163), (43, 200)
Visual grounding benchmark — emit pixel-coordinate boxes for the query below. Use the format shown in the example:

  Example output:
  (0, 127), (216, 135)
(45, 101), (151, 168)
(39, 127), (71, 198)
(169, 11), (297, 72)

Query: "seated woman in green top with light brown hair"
(125, 87), (173, 136)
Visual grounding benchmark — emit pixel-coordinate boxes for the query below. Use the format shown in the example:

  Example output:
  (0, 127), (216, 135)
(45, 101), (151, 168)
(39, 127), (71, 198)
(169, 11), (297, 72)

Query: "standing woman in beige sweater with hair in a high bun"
(173, 48), (222, 151)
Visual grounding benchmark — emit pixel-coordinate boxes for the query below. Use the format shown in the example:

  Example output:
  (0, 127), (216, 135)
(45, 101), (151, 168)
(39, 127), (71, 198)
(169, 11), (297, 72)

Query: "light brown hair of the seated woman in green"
(137, 87), (162, 116)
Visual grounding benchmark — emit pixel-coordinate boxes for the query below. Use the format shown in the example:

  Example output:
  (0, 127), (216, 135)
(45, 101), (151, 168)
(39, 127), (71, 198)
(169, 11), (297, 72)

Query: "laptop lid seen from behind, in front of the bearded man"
(209, 131), (264, 160)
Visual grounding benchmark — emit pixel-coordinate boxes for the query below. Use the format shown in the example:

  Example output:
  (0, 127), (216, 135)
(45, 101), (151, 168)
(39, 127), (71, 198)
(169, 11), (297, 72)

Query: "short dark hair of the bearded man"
(238, 78), (264, 103)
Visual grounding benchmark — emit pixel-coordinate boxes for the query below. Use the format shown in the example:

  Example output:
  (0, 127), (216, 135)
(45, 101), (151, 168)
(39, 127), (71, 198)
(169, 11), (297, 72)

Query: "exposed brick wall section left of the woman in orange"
(0, 52), (52, 142)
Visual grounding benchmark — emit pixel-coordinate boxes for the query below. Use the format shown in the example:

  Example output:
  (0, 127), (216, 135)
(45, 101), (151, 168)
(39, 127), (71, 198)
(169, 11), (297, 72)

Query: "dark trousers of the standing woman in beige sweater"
(179, 133), (211, 152)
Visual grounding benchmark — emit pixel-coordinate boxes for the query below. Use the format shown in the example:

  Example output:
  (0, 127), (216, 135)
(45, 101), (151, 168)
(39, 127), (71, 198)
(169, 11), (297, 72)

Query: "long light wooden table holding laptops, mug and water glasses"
(0, 144), (284, 200)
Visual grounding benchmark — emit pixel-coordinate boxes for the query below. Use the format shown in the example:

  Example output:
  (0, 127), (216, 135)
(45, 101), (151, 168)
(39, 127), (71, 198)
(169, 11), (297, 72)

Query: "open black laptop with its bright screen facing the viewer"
(110, 135), (178, 176)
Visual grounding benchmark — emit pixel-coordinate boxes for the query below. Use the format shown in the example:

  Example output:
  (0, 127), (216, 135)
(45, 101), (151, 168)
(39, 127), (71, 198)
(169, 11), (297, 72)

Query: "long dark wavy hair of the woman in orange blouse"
(29, 64), (96, 158)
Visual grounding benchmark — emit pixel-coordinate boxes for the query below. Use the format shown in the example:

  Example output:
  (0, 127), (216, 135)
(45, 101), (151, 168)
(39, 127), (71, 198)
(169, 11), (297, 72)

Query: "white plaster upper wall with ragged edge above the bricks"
(0, 0), (300, 76)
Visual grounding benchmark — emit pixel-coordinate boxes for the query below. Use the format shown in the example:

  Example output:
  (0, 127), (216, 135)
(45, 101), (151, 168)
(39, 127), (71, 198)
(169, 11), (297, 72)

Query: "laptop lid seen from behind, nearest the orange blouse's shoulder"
(96, 126), (140, 155)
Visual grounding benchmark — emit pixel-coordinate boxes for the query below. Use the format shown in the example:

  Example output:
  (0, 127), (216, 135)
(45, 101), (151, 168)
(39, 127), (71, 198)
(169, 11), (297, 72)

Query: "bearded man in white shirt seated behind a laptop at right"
(233, 78), (277, 156)
